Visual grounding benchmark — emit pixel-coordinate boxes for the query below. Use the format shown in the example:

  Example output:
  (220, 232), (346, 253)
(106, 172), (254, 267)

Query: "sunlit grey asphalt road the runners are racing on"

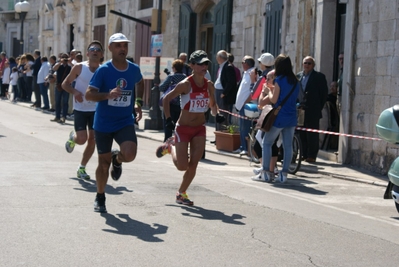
(0, 101), (399, 267)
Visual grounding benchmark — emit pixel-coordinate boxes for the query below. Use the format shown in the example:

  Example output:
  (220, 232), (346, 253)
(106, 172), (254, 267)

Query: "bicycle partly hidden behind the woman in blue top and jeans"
(249, 107), (302, 174)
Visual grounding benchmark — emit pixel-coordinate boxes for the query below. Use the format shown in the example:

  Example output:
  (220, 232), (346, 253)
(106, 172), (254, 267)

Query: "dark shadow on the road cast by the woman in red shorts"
(166, 205), (246, 225)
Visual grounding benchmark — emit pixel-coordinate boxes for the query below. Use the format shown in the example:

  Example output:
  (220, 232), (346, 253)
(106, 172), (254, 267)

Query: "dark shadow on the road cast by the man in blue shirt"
(101, 213), (168, 242)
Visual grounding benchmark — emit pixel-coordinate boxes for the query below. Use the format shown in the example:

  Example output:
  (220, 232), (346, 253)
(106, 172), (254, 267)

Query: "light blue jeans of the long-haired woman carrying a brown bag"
(262, 126), (295, 173)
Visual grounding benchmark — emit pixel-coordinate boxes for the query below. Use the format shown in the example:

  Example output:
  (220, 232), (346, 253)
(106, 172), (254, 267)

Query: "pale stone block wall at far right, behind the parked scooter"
(352, 0), (399, 174)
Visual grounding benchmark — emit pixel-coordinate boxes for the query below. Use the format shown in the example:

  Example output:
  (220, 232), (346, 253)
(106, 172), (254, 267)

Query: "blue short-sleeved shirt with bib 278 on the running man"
(89, 60), (143, 133)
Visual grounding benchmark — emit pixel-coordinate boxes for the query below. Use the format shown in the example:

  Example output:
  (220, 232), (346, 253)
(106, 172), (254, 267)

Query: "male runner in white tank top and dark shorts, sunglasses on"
(62, 41), (104, 180)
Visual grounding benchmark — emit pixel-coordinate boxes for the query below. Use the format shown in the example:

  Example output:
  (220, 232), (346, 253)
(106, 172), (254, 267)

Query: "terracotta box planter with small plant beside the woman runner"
(214, 124), (241, 152)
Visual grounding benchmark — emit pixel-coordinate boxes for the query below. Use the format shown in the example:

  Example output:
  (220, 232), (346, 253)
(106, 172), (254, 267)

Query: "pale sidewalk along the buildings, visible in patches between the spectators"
(10, 100), (388, 187)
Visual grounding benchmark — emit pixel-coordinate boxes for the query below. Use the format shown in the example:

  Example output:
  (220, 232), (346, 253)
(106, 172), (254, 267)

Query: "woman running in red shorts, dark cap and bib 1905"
(156, 50), (225, 206)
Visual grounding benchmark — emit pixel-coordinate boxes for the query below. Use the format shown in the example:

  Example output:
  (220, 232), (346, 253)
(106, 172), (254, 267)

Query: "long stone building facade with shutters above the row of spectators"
(0, 0), (399, 174)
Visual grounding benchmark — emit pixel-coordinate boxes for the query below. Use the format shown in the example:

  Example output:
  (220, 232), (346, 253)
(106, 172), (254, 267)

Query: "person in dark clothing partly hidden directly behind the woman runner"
(159, 59), (187, 142)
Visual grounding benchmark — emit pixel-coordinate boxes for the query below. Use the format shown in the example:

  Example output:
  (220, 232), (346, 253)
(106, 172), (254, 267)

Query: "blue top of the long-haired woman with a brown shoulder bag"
(273, 76), (299, 128)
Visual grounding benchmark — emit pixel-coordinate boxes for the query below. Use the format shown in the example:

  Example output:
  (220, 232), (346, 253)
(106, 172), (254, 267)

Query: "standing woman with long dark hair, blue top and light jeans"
(260, 55), (299, 183)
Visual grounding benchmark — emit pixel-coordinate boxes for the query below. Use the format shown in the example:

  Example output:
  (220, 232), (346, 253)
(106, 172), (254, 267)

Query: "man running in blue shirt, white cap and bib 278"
(86, 33), (144, 212)
